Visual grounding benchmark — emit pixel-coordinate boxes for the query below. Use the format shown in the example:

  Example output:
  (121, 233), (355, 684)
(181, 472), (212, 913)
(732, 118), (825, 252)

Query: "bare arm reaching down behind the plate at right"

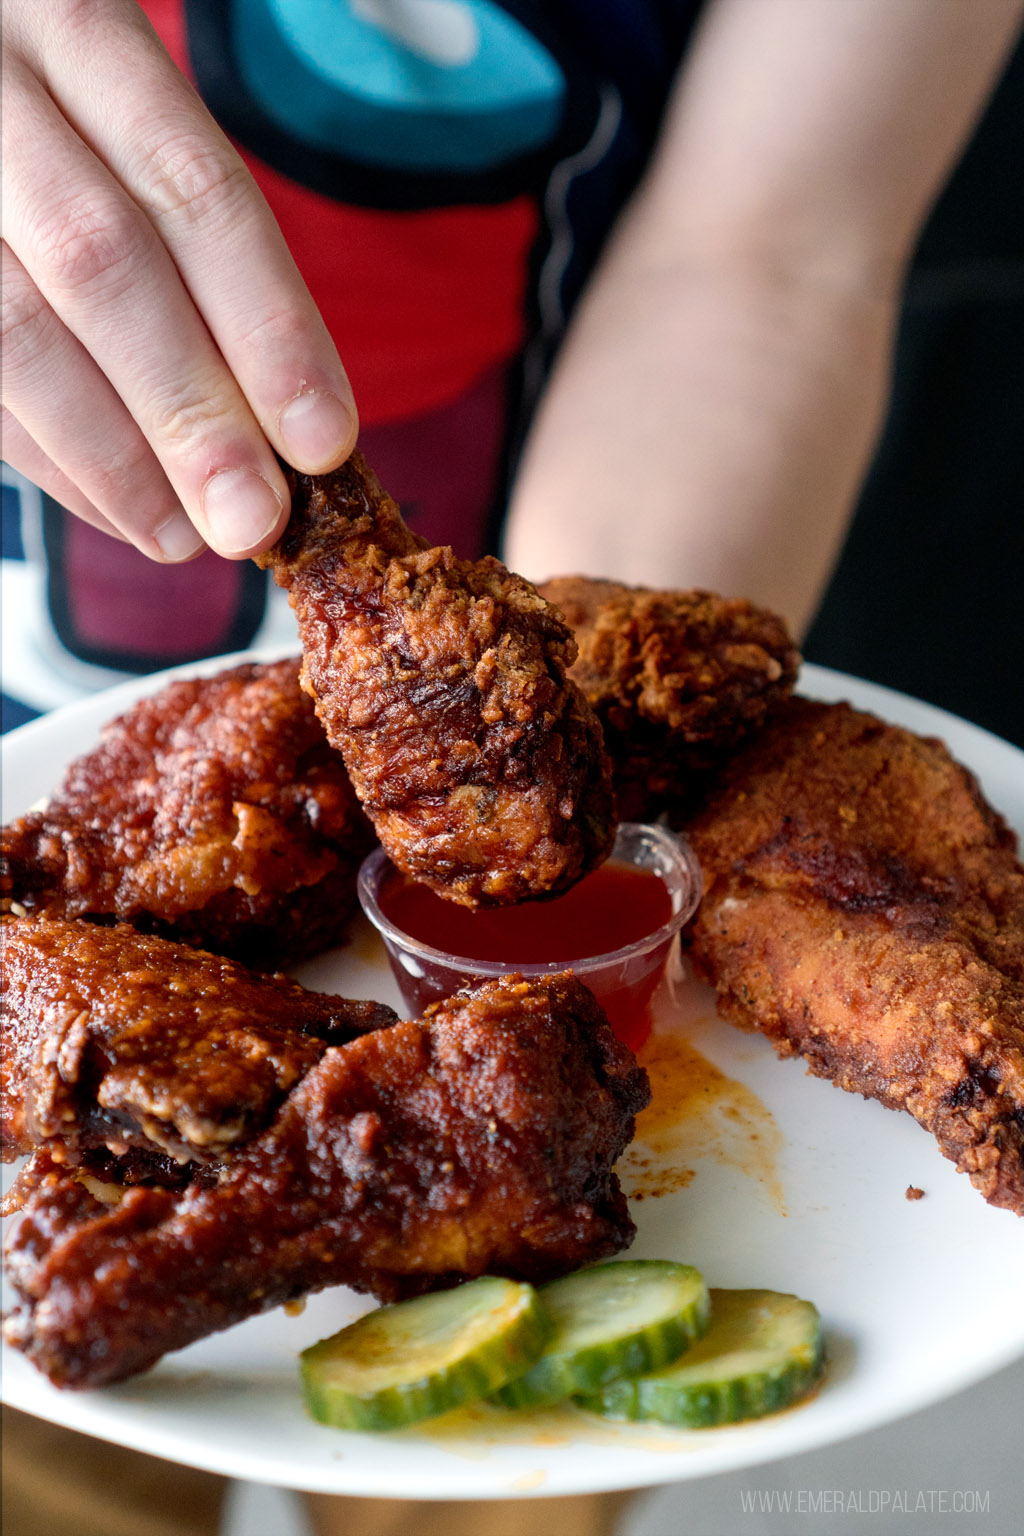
(505, 0), (1021, 631)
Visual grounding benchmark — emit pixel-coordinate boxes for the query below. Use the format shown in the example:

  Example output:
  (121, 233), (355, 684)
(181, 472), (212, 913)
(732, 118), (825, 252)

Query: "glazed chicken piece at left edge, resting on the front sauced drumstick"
(0, 917), (398, 1177)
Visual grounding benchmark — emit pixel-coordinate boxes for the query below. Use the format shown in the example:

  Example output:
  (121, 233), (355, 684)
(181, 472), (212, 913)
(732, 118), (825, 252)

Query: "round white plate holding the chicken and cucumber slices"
(3, 657), (1024, 1499)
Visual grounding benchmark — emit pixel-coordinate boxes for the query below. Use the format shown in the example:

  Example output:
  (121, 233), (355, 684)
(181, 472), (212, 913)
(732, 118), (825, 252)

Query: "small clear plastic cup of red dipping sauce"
(359, 823), (700, 1051)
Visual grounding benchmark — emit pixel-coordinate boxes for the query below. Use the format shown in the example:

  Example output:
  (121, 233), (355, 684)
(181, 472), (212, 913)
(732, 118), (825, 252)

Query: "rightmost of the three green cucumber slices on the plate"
(577, 1290), (824, 1428)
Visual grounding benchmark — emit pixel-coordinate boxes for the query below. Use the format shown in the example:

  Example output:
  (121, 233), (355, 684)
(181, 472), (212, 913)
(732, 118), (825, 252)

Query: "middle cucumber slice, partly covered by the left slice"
(493, 1260), (708, 1409)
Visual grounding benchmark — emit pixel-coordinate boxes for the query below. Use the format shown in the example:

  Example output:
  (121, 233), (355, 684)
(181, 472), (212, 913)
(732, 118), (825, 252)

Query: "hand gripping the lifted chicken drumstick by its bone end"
(3, 0), (358, 561)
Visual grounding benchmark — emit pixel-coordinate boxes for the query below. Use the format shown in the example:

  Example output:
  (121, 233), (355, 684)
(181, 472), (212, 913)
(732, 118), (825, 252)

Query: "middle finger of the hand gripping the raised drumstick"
(3, 49), (286, 556)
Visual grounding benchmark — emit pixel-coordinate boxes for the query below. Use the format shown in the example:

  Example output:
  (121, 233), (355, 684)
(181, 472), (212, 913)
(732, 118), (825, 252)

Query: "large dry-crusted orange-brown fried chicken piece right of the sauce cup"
(688, 697), (1024, 1213)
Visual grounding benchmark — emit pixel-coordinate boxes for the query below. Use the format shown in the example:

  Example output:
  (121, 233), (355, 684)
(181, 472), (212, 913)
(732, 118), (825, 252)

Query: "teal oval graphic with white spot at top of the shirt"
(232, 0), (565, 172)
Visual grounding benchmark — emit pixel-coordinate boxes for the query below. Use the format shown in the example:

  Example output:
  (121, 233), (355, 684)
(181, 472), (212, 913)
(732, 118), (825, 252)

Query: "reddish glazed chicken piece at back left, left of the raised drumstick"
(2, 659), (373, 969)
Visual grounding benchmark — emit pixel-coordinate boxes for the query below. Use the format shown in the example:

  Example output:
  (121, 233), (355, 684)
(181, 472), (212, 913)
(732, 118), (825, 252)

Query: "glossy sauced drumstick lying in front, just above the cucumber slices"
(3, 972), (649, 1387)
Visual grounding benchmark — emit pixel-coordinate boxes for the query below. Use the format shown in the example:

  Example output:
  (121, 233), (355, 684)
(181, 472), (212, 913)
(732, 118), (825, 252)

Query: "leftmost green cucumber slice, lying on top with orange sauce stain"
(299, 1275), (548, 1430)
